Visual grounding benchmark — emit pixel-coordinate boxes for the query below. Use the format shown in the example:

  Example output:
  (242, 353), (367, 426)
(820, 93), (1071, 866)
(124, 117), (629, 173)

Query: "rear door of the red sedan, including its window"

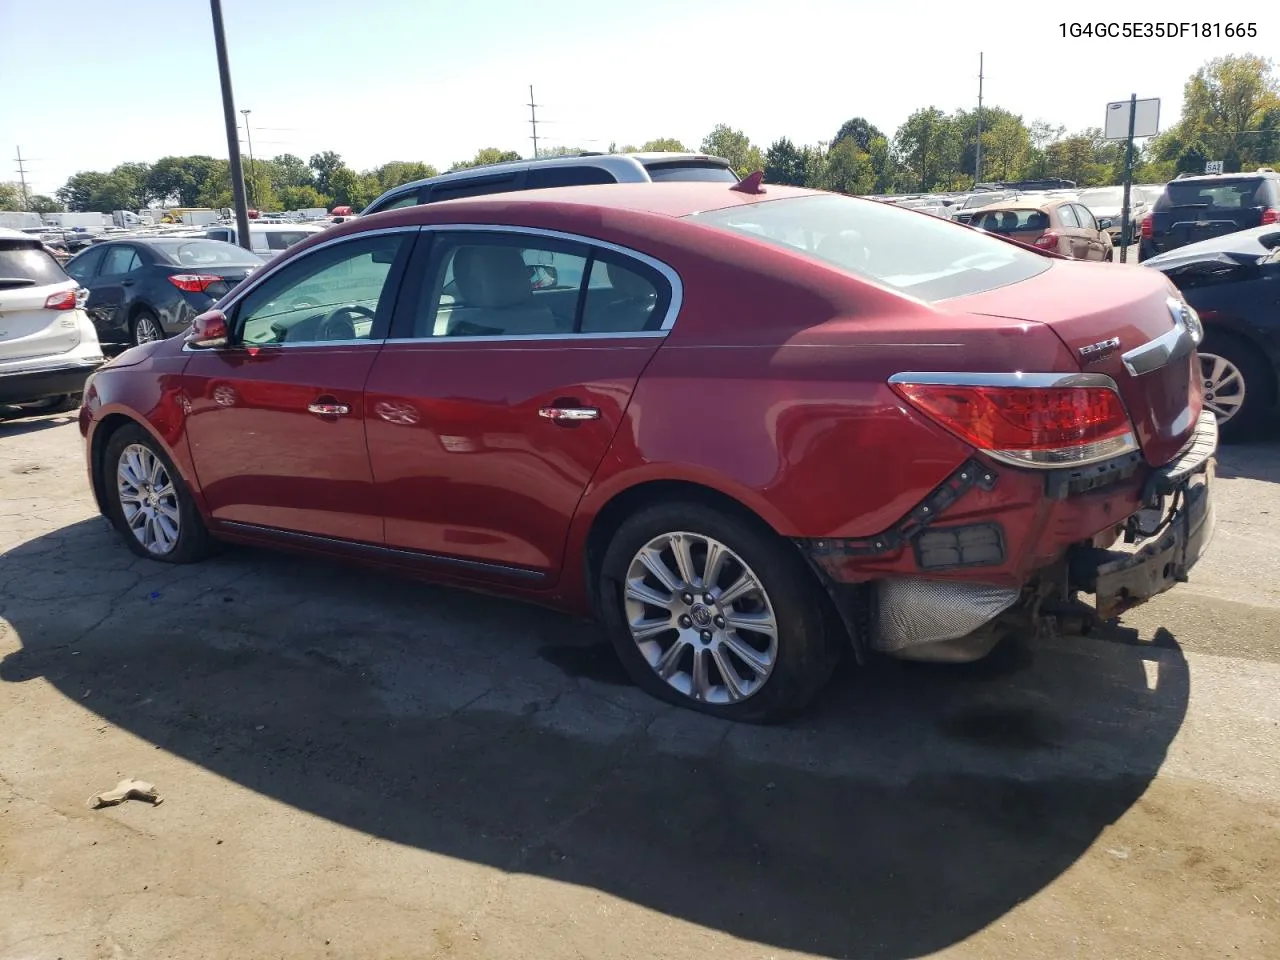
(365, 229), (673, 585)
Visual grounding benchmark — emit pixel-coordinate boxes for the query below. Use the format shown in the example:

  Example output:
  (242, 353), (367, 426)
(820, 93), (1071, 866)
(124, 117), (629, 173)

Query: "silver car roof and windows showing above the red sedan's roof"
(361, 154), (737, 216)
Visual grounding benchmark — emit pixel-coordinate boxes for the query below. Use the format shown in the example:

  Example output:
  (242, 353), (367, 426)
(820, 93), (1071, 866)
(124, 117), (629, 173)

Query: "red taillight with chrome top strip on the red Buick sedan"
(890, 374), (1138, 467)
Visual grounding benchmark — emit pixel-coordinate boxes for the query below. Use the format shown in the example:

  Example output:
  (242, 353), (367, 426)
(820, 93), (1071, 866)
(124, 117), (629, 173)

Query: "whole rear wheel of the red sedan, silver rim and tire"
(600, 503), (838, 723)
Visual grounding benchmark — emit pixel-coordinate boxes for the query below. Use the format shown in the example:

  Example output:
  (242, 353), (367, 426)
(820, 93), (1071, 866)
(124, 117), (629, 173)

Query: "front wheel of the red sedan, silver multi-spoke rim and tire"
(102, 426), (210, 563)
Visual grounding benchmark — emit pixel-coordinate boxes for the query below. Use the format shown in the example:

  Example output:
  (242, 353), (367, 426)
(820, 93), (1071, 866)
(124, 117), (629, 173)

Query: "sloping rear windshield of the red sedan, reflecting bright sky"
(689, 196), (1050, 301)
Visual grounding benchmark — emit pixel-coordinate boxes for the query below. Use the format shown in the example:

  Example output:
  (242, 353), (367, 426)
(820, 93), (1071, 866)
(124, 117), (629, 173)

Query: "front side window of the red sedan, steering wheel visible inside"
(234, 233), (404, 346)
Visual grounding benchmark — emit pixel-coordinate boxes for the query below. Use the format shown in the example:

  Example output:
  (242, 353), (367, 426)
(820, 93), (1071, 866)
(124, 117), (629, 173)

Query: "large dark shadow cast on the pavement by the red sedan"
(0, 518), (1188, 960)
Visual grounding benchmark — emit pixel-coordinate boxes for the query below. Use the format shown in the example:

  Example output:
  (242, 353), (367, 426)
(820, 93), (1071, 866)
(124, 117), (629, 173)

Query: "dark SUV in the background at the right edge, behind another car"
(1140, 168), (1280, 260)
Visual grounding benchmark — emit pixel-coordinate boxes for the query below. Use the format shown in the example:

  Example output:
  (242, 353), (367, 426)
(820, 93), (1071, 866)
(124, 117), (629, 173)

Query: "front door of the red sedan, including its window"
(184, 230), (416, 544)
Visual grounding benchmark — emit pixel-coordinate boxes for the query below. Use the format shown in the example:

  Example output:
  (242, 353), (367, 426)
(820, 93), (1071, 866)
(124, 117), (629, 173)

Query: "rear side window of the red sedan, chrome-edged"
(410, 232), (671, 338)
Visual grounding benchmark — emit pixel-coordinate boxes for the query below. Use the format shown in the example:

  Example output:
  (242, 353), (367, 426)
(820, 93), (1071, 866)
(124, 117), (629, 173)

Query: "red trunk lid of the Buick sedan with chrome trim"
(947, 261), (1202, 465)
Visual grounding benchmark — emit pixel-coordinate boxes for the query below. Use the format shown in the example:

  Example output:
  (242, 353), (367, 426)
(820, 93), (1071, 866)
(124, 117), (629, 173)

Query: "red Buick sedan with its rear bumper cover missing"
(81, 178), (1217, 721)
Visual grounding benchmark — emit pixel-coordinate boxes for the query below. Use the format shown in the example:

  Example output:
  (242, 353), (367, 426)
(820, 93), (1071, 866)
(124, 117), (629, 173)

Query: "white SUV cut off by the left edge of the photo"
(0, 228), (104, 419)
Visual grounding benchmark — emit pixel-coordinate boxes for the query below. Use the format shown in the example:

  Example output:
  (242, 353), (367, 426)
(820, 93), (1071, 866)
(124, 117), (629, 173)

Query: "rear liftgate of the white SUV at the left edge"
(0, 238), (79, 364)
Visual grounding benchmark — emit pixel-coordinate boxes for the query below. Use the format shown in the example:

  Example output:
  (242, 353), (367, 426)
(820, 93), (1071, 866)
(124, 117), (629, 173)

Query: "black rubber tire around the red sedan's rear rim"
(599, 502), (842, 723)
